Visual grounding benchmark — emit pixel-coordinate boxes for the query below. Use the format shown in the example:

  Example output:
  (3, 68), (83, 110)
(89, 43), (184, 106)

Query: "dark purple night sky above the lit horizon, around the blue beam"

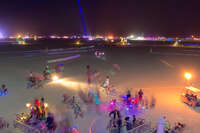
(0, 0), (200, 36)
